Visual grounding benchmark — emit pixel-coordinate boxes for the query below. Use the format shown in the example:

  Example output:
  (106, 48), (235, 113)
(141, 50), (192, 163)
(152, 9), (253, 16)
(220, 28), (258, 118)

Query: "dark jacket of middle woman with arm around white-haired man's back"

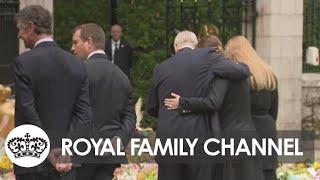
(179, 78), (256, 133)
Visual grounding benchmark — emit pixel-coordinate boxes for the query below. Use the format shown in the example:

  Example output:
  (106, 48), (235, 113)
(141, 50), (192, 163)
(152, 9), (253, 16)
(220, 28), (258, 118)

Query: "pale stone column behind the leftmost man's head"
(19, 0), (53, 54)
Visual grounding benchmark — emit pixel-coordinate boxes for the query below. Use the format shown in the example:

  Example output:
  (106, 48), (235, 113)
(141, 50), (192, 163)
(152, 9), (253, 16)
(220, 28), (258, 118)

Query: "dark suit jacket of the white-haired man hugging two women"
(147, 48), (250, 138)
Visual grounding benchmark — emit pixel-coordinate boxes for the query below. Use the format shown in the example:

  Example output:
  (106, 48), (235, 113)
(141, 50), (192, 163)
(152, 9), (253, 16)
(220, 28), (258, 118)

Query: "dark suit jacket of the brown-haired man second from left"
(85, 54), (136, 150)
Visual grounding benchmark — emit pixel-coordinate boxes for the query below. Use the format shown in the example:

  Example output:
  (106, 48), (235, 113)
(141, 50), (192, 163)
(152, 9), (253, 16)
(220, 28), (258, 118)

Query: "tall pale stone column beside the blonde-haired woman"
(256, 0), (303, 130)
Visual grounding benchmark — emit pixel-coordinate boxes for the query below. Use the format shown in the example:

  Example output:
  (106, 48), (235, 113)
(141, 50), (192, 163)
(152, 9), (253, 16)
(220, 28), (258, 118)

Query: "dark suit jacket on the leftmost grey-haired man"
(14, 42), (91, 174)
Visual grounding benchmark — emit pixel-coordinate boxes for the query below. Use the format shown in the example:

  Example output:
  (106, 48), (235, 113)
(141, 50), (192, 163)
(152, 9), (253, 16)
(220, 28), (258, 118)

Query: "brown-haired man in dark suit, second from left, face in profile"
(72, 23), (136, 180)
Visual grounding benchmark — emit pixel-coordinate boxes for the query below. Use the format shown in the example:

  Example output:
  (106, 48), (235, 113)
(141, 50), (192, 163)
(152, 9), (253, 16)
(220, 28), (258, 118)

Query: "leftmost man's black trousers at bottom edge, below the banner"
(16, 170), (76, 180)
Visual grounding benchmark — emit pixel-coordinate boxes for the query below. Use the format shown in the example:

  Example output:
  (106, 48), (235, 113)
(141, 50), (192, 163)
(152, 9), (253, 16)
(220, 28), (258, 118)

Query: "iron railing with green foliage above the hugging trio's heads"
(166, 0), (256, 55)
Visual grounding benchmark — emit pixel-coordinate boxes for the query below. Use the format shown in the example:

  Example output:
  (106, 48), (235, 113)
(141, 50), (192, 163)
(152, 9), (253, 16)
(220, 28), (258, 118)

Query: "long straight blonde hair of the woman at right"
(225, 36), (277, 91)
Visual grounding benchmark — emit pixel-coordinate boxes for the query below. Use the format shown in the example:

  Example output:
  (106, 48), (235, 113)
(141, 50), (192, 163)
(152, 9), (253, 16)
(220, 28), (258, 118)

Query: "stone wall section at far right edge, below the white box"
(302, 73), (320, 136)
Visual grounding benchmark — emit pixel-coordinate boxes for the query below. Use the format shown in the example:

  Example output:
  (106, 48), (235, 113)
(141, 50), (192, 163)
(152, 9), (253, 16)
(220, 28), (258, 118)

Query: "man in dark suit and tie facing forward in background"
(105, 24), (132, 77)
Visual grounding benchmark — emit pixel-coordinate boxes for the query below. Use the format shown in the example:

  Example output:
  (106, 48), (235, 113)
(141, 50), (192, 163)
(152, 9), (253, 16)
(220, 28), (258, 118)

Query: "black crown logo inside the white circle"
(7, 133), (48, 158)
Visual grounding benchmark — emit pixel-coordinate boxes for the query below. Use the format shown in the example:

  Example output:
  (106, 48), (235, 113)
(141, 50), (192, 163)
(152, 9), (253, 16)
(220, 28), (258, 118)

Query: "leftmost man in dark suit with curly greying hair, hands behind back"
(14, 5), (91, 180)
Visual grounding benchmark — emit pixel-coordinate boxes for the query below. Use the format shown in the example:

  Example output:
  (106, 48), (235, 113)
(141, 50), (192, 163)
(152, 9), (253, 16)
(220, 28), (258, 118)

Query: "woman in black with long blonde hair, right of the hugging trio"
(225, 36), (278, 180)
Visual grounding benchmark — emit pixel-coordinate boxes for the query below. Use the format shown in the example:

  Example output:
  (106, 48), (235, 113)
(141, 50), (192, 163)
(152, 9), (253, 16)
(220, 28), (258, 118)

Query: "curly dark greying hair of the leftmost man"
(15, 5), (52, 34)
